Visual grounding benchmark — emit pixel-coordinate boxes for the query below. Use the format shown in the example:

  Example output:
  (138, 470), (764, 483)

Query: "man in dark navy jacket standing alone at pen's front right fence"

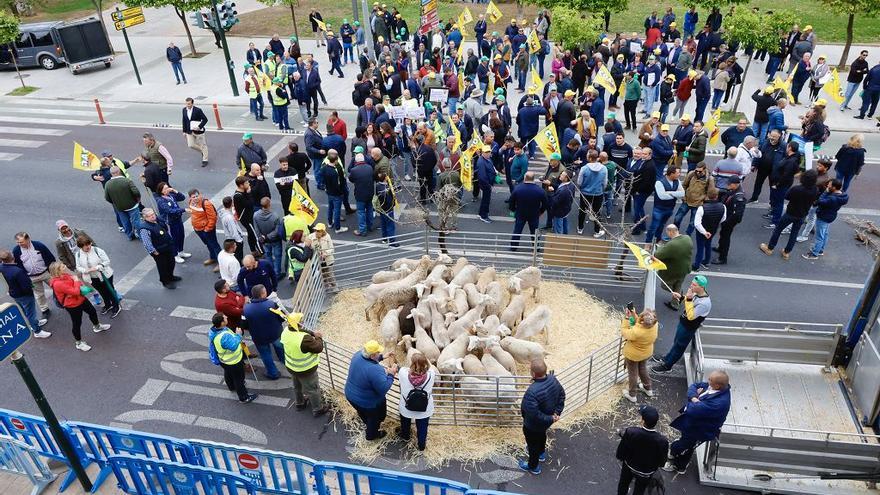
(519, 359), (565, 475)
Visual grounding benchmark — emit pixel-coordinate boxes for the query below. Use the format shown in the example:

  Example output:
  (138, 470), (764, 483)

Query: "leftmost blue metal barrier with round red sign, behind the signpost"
(0, 409), (85, 492)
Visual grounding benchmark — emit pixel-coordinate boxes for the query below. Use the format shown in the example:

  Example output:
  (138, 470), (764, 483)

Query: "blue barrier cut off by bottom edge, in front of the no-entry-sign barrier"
(106, 454), (256, 495)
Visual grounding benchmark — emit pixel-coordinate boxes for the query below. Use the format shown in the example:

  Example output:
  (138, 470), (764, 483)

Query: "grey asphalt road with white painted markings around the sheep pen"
(0, 101), (880, 494)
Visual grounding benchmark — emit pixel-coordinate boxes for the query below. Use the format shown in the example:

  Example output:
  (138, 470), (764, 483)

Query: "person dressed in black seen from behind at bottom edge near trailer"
(616, 404), (669, 495)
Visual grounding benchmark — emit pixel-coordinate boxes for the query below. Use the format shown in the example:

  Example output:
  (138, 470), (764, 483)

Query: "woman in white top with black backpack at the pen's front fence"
(397, 353), (435, 450)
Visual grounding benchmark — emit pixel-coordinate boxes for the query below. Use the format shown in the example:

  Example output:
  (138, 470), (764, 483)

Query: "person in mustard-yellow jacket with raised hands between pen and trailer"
(620, 308), (658, 402)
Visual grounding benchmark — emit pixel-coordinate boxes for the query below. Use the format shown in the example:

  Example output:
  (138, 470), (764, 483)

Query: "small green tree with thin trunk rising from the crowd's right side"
(724, 9), (797, 112)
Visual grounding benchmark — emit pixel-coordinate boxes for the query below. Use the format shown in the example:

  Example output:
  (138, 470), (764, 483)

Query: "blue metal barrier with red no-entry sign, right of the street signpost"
(189, 440), (317, 495)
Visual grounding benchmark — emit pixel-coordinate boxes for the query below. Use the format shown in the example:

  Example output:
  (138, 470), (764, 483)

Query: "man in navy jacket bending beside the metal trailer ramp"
(663, 370), (730, 474)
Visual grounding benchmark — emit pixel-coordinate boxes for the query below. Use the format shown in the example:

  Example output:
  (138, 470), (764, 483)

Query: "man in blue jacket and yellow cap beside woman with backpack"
(345, 340), (397, 440)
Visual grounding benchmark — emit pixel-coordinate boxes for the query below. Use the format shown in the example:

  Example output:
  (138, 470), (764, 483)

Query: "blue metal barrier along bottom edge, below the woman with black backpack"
(314, 462), (470, 495)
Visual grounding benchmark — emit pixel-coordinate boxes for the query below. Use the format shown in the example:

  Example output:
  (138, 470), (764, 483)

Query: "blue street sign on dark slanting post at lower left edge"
(0, 304), (92, 493)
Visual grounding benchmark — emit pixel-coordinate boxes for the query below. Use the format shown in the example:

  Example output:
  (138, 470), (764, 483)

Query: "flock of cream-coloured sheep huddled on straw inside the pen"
(364, 255), (550, 390)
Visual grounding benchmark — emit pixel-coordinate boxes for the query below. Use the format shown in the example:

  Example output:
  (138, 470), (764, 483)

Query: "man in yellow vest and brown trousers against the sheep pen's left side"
(281, 313), (330, 418)
